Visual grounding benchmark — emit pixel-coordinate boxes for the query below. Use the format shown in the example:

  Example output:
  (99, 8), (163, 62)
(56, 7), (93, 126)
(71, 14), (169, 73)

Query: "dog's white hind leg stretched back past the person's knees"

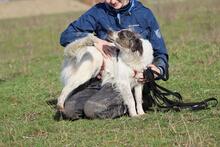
(57, 51), (102, 111)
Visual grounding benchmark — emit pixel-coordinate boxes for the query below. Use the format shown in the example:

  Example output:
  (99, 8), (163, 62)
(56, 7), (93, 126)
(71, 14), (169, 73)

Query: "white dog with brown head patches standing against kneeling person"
(57, 30), (153, 116)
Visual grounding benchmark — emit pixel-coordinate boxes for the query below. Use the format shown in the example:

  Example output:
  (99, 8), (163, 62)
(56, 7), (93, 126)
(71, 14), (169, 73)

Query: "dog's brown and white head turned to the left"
(108, 29), (143, 55)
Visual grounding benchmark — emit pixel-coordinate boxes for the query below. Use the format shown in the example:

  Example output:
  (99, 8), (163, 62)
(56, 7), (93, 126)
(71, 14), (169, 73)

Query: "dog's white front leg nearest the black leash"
(134, 85), (144, 115)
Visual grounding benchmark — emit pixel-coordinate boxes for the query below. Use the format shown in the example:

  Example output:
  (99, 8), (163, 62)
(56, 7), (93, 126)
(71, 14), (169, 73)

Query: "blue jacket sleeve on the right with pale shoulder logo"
(148, 11), (169, 80)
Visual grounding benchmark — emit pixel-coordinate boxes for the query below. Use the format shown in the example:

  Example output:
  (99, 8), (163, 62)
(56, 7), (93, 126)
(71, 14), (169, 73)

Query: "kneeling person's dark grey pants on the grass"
(63, 79), (153, 120)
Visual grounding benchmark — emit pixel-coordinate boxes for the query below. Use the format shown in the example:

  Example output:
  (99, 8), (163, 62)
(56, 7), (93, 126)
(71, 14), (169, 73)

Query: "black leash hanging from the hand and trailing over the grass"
(144, 68), (218, 111)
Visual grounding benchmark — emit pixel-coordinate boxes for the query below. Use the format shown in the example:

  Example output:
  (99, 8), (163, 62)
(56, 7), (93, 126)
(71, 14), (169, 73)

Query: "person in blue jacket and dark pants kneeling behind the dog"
(60, 0), (168, 120)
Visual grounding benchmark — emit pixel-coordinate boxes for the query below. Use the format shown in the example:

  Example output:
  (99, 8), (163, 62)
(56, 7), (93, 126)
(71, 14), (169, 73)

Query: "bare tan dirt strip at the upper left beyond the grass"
(0, 0), (89, 19)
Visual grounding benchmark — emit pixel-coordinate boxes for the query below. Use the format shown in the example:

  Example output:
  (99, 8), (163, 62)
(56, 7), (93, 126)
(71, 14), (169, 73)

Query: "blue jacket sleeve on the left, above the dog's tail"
(60, 7), (97, 47)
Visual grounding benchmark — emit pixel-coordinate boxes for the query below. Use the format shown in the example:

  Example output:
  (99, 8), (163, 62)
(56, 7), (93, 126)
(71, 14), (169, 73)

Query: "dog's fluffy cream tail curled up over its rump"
(64, 34), (97, 63)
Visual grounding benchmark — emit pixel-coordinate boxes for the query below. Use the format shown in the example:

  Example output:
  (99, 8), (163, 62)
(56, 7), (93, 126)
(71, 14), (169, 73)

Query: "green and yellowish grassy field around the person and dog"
(0, 0), (220, 147)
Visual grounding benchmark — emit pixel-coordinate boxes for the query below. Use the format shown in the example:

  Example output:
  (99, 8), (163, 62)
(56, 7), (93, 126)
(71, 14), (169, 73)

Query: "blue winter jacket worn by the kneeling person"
(60, 0), (168, 78)
